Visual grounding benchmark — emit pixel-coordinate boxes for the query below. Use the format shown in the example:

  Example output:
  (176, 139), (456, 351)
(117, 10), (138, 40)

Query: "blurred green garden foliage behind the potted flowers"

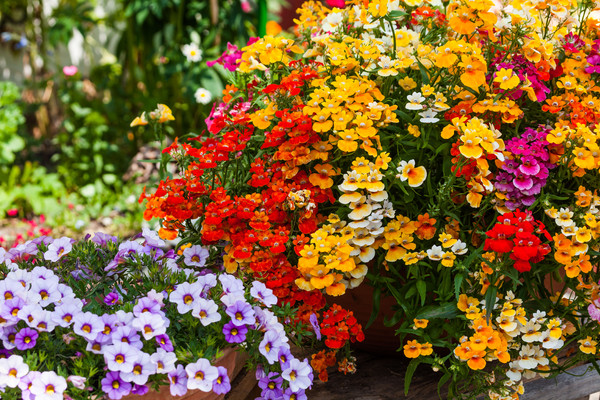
(0, 0), (285, 241)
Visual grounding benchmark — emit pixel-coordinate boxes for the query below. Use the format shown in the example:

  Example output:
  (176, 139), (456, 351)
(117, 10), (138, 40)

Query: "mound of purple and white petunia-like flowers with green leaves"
(0, 230), (312, 399)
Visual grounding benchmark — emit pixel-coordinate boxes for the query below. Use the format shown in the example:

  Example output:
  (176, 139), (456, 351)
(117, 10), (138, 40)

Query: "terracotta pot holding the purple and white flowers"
(122, 347), (248, 400)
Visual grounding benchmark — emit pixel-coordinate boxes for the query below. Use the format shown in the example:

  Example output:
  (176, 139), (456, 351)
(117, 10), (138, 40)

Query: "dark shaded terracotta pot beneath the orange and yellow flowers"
(327, 282), (401, 355)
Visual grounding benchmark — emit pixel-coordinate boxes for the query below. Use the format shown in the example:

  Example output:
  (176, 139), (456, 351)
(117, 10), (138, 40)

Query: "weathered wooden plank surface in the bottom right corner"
(519, 364), (600, 400)
